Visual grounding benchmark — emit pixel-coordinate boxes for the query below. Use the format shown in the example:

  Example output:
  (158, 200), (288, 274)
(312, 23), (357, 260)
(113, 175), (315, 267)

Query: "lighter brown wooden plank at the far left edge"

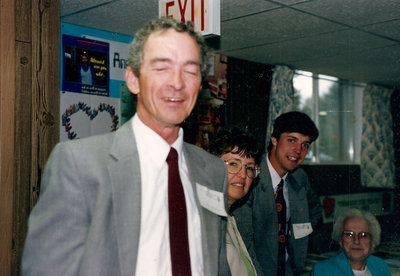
(0, 0), (15, 275)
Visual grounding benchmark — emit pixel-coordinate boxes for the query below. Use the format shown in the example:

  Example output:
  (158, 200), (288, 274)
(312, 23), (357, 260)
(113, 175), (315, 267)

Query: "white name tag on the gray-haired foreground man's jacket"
(196, 183), (227, 217)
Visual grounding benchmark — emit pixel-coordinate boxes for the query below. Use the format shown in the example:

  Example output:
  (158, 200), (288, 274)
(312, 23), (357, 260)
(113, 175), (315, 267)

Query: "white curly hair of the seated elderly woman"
(332, 209), (381, 246)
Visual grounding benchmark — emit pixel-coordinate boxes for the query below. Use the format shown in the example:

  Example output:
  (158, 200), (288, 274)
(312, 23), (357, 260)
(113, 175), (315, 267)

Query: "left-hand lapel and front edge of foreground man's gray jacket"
(108, 119), (141, 275)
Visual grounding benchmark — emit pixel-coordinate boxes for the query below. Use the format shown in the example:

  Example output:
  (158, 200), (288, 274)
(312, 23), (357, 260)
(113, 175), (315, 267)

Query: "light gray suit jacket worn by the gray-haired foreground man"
(22, 118), (230, 276)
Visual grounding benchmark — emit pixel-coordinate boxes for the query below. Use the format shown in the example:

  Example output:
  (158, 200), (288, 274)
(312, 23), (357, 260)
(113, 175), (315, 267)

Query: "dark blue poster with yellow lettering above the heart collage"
(62, 34), (109, 96)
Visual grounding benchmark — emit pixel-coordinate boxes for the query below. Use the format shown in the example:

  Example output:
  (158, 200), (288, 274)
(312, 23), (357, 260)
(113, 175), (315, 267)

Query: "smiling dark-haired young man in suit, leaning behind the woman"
(233, 112), (322, 276)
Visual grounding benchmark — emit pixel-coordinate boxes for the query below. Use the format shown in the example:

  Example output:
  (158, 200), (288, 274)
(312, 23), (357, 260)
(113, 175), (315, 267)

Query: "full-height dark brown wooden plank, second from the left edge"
(11, 0), (32, 275)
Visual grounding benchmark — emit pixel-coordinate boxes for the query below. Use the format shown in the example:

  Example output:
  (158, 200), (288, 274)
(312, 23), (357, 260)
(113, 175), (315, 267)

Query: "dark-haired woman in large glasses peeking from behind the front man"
(209, 128), (261, 276)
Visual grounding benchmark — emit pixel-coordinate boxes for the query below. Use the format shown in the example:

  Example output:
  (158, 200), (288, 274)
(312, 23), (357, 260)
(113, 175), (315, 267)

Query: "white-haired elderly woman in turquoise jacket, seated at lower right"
(312, 209), (391, 276)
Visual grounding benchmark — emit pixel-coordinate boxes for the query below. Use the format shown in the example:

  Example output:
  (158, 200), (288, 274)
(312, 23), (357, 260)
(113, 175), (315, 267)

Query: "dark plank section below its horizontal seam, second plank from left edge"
(13, 41), (32, 275)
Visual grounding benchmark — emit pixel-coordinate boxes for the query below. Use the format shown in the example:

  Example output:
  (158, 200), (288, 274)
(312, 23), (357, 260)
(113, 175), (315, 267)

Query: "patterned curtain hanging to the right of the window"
(361, 85), (395, 188)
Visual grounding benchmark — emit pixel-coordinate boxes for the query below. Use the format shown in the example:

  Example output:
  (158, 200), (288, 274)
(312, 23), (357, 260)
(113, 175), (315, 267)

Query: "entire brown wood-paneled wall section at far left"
(0, 0), (60, 275)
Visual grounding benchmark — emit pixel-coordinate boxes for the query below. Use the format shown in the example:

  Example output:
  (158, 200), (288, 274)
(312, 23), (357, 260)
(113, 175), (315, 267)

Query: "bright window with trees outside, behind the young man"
(293, 71), (364, 164)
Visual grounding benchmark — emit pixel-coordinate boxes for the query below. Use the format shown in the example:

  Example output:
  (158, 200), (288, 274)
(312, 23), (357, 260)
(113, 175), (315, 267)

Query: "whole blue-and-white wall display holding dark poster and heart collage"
(60, 22), (133, 141)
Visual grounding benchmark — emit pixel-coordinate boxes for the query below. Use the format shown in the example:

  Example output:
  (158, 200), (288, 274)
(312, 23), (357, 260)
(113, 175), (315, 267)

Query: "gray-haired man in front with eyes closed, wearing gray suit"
(22, 18), (230, 276)
